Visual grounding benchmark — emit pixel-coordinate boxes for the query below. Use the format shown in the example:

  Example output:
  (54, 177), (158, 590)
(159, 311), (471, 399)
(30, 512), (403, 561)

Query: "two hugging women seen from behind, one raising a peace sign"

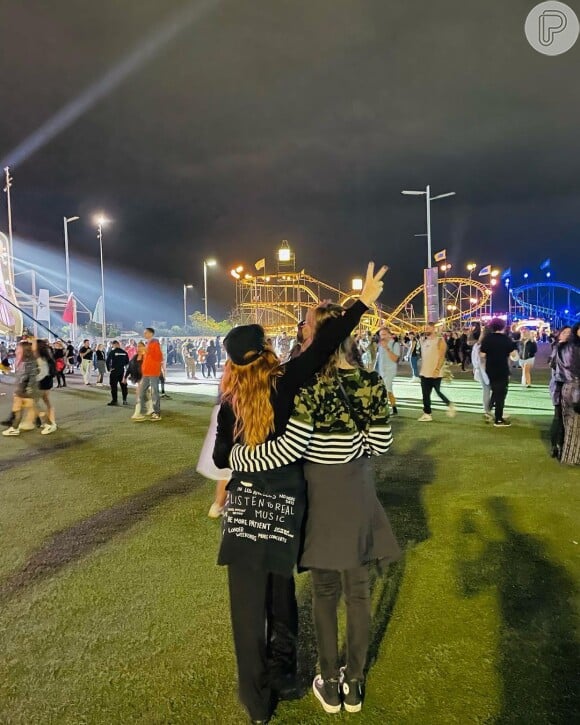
(214, 264), (400, 723)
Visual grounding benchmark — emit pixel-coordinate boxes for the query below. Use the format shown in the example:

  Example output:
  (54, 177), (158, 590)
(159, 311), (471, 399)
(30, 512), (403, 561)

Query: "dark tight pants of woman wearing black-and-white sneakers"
(311, 566), (371, 680)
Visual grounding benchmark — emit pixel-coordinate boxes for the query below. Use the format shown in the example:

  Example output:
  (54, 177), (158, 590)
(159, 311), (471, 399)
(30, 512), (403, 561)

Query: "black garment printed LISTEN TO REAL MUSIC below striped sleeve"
(218, 464), (306, 576)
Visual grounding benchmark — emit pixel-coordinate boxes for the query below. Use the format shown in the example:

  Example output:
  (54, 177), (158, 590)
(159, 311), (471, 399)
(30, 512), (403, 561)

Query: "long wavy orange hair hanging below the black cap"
(221, 345), (284, 448)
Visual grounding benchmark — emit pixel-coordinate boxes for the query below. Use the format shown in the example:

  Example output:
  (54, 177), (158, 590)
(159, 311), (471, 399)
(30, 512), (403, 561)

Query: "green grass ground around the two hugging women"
(0, 378), (580, 725)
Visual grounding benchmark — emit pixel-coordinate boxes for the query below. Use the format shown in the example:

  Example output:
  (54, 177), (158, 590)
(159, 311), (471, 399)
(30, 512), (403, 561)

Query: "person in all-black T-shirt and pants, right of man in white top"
(480, 317), (517, 428)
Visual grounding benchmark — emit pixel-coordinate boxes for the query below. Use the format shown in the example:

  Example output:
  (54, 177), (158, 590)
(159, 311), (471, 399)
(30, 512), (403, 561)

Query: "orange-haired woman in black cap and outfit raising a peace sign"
(214, 263), (387, 723)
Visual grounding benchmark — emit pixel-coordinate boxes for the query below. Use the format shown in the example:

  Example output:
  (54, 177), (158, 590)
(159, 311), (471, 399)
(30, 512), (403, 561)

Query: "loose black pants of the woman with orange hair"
(228, 564), (298, 720)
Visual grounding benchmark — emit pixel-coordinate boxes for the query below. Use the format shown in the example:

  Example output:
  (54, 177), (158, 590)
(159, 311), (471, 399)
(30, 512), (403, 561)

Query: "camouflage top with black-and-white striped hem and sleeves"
(230, 368), (393, 473)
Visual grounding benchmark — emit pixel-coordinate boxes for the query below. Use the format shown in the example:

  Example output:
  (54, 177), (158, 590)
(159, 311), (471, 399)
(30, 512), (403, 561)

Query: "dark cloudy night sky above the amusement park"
(0, 0), (580, 321)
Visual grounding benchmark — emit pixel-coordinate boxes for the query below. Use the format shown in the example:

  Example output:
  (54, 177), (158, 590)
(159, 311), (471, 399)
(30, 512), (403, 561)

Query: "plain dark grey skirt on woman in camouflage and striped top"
(300, 458), (401, 571)
